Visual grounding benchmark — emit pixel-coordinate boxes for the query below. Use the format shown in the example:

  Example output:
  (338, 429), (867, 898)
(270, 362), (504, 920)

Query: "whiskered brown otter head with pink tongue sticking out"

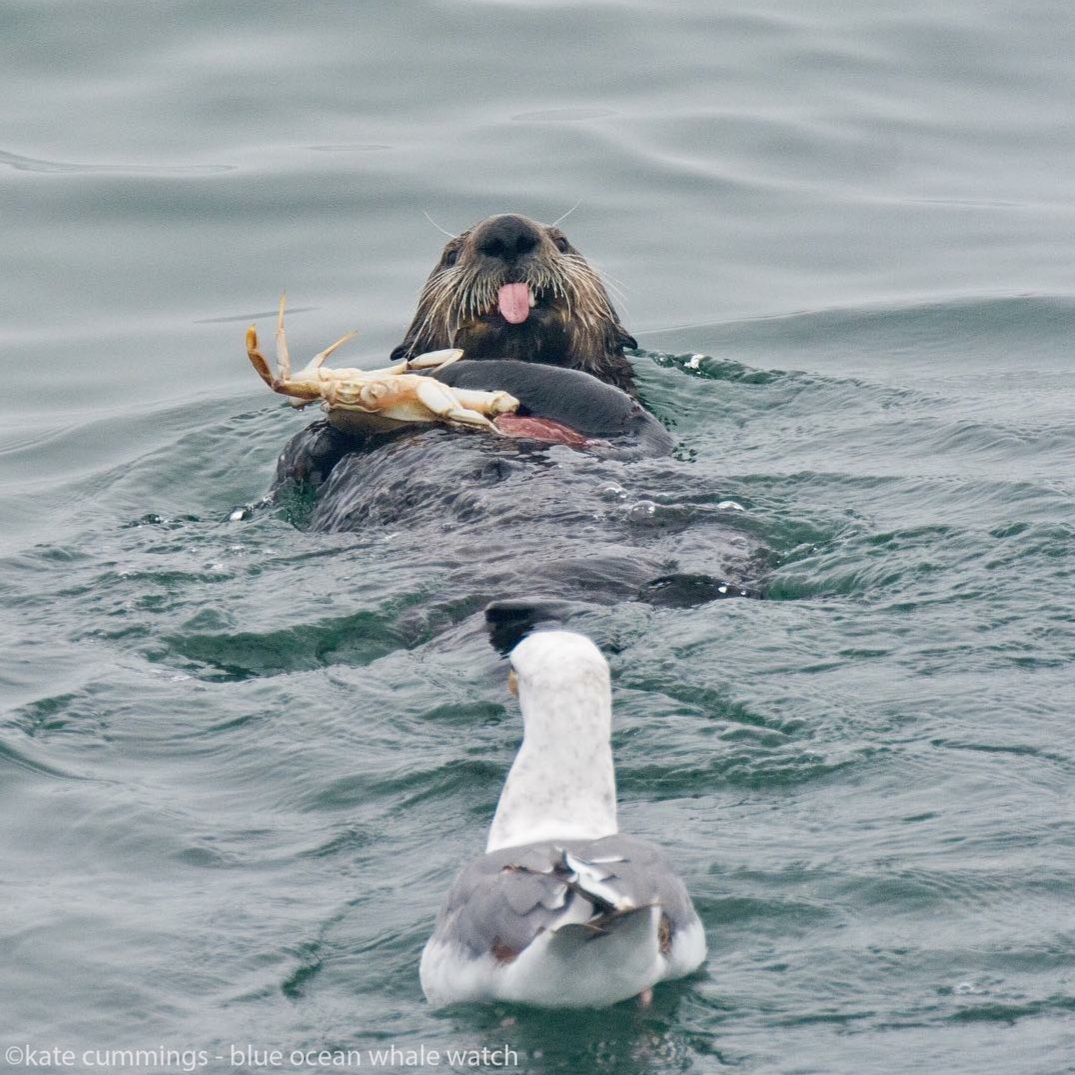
(392, 214), (637, 393)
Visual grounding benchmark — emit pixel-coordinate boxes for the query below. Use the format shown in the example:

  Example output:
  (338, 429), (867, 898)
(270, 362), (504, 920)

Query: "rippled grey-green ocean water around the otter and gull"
(0, 0), (1075, 1075)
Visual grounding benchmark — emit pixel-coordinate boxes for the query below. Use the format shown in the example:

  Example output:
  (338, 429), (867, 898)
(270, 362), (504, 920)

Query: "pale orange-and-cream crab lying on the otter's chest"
(246, 296), (519, 434)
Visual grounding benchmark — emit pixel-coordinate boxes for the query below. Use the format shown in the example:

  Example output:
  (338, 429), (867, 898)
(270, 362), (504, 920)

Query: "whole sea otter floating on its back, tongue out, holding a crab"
(255, 215), (753, 610)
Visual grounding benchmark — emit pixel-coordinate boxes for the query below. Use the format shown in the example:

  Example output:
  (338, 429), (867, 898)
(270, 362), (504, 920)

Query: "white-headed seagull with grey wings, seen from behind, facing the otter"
(420, 630), (706, 1008)
